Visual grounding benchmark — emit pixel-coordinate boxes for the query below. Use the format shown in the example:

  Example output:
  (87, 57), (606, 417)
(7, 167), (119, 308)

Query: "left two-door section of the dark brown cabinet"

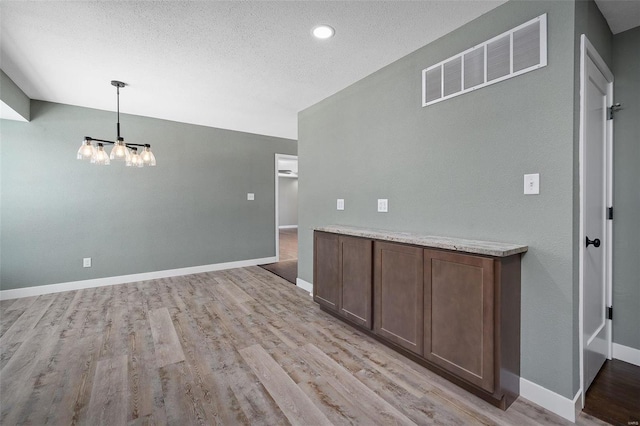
(313, 232), (373, 330)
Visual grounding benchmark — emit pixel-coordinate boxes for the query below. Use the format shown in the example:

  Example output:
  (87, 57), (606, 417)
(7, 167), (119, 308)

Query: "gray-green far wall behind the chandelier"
(0, 101), (297, 290)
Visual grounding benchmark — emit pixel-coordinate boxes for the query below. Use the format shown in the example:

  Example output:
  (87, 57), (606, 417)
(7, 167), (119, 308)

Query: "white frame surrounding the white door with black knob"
(577, 34), (613, 408)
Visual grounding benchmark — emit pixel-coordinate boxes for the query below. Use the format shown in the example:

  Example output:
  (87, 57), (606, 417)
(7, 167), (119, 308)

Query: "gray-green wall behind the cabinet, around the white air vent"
(298, 1), (579, 398)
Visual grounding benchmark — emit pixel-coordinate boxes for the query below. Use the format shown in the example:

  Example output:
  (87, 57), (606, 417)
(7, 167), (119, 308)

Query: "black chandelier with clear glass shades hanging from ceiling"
(76, 80), (156, 167)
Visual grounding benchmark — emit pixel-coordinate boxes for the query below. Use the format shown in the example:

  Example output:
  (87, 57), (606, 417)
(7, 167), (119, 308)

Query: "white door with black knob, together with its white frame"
(578, 34), (613, 408)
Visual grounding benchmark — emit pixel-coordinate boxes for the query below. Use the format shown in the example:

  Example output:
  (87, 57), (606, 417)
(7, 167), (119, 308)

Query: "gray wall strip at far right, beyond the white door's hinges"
(613, 27), (640, 349)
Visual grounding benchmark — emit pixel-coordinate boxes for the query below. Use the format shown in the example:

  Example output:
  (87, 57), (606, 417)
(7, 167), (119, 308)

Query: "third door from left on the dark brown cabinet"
(373, 241), (424, 355)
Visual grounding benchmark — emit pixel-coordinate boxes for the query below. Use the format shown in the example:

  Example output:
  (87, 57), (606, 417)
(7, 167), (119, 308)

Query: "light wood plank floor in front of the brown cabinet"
(0, 267), (602, 426)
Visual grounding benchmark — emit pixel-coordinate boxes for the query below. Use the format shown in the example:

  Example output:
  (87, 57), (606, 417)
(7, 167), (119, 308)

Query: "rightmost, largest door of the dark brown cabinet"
(424, 250), (494, 392)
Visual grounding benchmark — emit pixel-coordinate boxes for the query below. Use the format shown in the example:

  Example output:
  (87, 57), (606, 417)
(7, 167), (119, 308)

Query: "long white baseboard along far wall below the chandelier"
(0, 257), (277, 300)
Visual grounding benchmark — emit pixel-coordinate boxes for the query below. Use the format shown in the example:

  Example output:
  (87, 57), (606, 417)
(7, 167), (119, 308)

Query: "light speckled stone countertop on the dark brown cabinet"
(315, 225), (528, 257)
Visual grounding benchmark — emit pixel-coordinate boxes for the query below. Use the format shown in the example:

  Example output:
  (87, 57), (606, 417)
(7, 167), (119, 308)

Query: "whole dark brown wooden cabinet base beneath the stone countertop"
(313, 231), (526, 410)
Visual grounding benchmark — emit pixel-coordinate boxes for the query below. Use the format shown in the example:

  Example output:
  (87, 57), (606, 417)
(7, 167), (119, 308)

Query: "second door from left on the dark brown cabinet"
(340, 236), (373, 330)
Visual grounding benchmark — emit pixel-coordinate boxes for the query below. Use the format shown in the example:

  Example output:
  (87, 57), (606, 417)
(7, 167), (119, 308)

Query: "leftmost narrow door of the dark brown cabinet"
(313, 231), (340, 312)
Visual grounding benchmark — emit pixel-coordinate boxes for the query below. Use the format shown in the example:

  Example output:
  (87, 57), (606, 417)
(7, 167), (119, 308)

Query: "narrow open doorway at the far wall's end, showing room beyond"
(260, 154), (298, 285)
